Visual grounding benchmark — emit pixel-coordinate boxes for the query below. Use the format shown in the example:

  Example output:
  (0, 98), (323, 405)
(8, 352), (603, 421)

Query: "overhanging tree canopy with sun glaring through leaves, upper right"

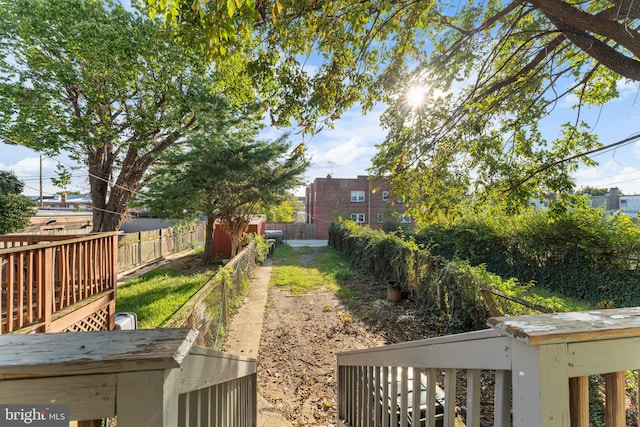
(147, 0), (640, 216)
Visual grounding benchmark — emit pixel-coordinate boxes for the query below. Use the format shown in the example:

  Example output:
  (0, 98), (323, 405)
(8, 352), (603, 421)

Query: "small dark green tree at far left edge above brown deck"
(0, 171), (35, 234)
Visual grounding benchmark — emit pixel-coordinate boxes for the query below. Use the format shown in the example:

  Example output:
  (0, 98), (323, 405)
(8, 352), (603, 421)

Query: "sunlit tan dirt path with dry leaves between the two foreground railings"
(258, 288), (384, 426)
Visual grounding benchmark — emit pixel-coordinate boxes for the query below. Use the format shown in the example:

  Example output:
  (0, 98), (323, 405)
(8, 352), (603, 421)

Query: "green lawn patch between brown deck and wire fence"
(116, 268), (214, 329)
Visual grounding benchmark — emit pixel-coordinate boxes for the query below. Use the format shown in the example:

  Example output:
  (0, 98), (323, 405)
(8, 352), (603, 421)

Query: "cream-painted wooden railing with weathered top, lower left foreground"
(0, 329), (257, 427)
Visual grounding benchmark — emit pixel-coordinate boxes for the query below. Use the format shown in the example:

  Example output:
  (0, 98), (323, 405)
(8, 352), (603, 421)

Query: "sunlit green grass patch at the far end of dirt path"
(271, 245), (351, 294)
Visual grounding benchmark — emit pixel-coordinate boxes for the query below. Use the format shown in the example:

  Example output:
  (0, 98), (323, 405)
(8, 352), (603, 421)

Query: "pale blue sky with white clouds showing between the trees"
(0, 85), (640, 201)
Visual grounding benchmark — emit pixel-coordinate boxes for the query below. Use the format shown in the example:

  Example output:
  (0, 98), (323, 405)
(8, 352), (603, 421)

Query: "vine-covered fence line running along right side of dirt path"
(329, 217), (587, 332)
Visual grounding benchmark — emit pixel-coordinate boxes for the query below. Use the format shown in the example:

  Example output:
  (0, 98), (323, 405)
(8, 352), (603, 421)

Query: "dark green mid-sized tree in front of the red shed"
(145, 105), (308, 259)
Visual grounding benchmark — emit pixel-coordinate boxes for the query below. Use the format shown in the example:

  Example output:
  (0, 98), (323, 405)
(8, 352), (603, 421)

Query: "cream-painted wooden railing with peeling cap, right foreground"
(338, 308), (640, 427)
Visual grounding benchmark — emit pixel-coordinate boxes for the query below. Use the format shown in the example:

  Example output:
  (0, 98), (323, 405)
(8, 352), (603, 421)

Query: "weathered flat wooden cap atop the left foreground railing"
(0, 329), (198, 380)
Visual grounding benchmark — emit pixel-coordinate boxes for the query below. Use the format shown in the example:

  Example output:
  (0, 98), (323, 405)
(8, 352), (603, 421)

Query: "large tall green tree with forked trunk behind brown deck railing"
(0, 0), (217, 231)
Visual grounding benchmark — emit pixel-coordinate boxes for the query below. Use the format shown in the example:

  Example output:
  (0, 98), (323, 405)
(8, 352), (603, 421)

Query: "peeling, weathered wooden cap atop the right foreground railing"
(487, 307), (640, 345)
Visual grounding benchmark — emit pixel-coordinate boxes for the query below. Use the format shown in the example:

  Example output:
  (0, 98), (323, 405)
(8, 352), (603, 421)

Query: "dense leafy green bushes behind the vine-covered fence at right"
(415, 205), (640, 308)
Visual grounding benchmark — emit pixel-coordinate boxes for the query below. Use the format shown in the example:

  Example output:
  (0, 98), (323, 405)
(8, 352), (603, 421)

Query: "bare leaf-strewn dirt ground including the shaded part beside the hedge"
(258, 249), (440, 426)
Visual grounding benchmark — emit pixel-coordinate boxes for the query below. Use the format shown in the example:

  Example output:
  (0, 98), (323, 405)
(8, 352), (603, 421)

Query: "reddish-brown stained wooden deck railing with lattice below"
(0, 233), (117, 334)
